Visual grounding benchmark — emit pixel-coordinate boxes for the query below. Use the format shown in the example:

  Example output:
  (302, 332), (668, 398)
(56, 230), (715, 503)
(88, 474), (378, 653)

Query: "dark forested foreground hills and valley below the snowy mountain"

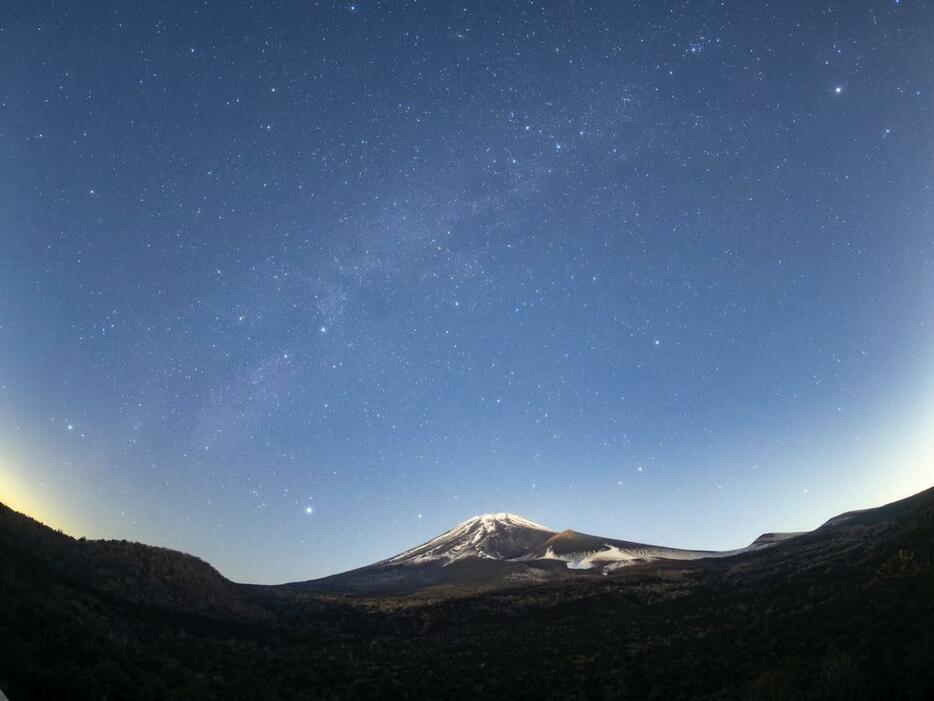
(0, 490), (934, 701)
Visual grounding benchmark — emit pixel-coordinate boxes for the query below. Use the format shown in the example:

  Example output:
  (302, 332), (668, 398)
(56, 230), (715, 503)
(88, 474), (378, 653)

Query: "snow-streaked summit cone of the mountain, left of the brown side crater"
(382, 513), (555, 565)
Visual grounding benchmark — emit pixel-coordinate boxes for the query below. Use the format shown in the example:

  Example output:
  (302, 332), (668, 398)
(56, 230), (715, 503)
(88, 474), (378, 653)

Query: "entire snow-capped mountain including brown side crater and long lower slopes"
(289, 513), (798, 594)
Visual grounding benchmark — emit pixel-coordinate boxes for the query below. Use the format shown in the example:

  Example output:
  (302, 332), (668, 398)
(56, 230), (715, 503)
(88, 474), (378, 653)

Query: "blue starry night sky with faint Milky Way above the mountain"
(0, 0), (934, 582)
